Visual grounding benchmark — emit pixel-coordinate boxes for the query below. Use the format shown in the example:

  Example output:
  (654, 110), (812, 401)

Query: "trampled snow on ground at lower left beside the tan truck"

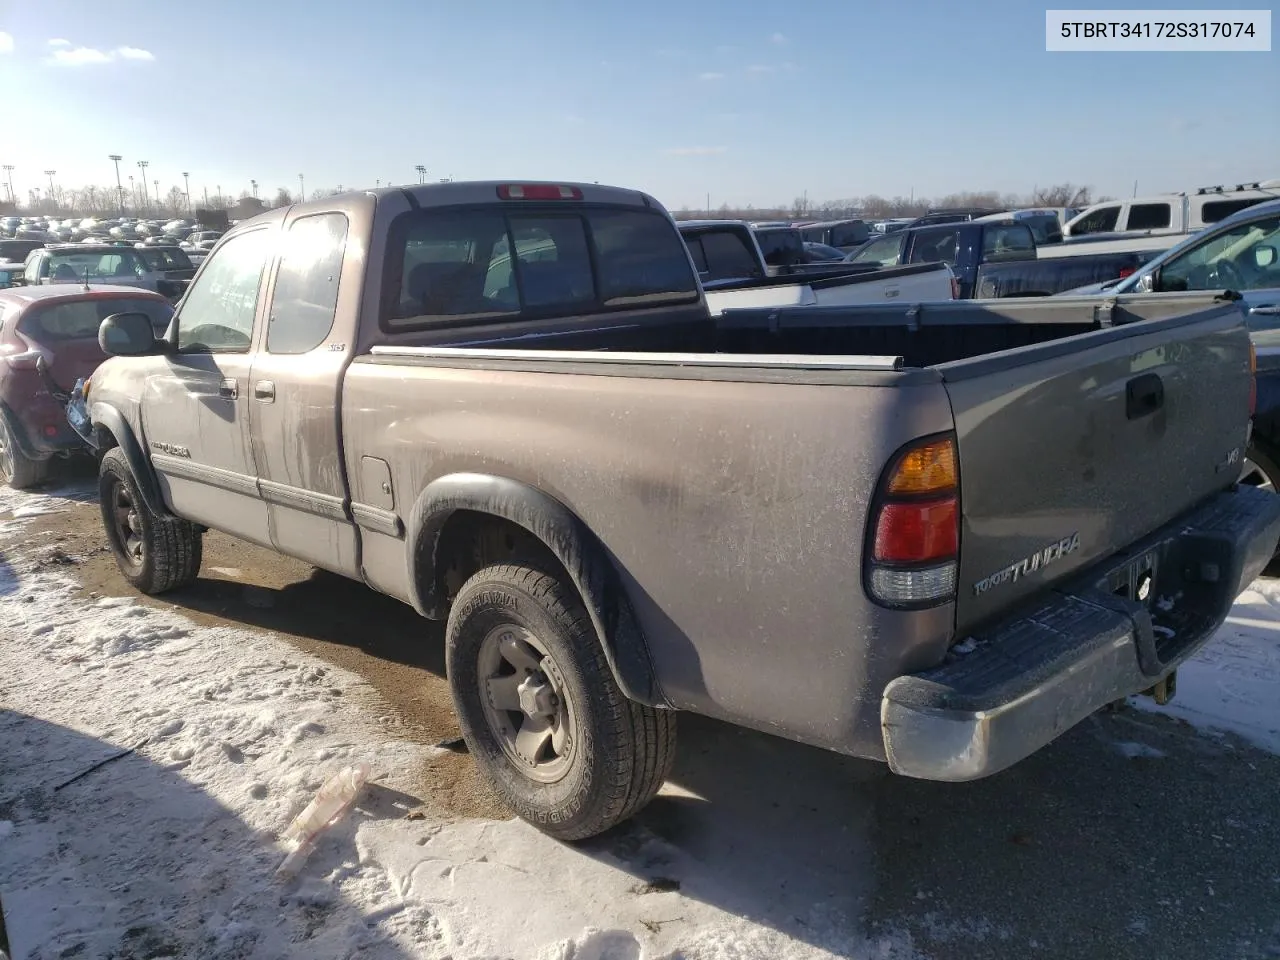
(0, 489), (915, 960)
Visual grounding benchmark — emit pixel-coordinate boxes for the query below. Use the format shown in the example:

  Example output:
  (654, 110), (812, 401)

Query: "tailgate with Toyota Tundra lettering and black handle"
(937, 296), (1251, 636)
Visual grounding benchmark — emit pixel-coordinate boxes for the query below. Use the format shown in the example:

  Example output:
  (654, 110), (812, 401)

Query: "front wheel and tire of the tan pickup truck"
(97, 447), (204, 594)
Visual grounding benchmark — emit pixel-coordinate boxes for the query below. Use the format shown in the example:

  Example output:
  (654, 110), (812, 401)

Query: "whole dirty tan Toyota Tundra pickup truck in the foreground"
(68, 183), (1280, 838)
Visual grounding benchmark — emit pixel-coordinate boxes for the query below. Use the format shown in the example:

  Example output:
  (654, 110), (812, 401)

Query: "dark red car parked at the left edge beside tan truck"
(0, 284), (173, 489)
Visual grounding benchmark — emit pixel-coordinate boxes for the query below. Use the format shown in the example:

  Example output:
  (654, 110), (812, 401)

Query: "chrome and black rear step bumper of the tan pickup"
(881, 488), (1280, 781)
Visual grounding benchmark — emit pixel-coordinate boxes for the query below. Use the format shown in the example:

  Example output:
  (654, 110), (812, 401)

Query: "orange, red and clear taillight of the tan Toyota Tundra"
(865, 435), (960, 607)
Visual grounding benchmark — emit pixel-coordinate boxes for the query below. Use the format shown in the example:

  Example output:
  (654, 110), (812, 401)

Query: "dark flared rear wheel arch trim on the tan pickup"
(406, 474), (668, 707)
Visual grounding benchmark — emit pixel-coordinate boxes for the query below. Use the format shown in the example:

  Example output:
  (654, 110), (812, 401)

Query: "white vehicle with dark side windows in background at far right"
(1062, 179), (1280, 237)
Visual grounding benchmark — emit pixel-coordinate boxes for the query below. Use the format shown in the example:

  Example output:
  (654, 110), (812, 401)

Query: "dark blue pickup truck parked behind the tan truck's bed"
(847, 219), (1158, 300)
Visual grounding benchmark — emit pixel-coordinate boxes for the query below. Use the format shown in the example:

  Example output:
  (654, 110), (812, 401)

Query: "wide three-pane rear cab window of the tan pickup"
(384, 207), (698, 328)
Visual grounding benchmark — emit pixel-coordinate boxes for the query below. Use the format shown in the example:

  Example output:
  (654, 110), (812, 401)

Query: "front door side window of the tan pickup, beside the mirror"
(178, 229), (275, 353)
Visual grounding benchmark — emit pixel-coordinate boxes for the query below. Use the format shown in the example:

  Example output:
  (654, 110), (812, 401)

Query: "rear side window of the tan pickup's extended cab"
(266, 214), (347, 353)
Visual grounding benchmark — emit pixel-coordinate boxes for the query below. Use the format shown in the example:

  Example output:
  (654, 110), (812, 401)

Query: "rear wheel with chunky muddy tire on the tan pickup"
(445, 562), (676, 840)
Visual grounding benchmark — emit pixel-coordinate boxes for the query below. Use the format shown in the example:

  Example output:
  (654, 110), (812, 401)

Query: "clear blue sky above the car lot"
(0, 0), (1280, 207)
